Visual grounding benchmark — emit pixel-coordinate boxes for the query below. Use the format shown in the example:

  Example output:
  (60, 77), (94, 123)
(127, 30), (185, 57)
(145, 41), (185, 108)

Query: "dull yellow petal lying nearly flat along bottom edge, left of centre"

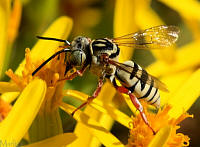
(24, 133), (77, 147)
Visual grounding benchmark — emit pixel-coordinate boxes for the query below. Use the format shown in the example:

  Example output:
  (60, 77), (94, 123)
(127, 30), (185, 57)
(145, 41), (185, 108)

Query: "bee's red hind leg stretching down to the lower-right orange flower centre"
(115, 86), (156, 135)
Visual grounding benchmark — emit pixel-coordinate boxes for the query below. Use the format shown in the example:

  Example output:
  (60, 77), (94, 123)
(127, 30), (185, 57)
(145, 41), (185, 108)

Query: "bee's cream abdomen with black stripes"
(115, 61), (160, 108)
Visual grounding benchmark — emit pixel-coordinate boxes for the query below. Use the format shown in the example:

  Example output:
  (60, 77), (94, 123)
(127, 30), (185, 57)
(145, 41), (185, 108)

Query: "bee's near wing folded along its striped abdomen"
(110, 60), (168, 92)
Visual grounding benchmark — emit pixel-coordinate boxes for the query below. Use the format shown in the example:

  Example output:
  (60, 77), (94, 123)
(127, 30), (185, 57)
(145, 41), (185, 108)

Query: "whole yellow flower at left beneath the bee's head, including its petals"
(0, 14), (123, 146)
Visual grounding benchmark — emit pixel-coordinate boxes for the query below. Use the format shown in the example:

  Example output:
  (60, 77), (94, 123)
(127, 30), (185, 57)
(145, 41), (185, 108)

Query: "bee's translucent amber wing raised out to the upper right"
(112, 25), (180, 49)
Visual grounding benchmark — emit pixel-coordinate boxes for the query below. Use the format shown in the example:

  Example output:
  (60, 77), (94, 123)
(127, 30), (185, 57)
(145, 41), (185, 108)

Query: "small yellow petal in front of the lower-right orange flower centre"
(148, 126), (172, 147)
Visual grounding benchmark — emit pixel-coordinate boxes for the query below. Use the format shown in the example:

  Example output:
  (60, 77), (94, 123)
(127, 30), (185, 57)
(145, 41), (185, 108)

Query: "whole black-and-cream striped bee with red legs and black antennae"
(32, 25), (179, 133)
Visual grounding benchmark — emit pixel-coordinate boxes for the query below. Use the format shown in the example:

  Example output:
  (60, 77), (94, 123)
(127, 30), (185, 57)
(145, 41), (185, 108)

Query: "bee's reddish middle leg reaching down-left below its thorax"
(71, 79), (103, 116)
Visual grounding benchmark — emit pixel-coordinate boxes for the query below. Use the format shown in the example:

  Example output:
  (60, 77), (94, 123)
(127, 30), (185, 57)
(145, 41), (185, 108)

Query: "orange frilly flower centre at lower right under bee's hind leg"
(127, 102), (193, 147)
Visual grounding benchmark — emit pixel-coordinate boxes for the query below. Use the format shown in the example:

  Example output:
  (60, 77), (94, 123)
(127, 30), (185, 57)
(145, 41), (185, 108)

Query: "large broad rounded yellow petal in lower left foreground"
(0, 79), (46, 144)
